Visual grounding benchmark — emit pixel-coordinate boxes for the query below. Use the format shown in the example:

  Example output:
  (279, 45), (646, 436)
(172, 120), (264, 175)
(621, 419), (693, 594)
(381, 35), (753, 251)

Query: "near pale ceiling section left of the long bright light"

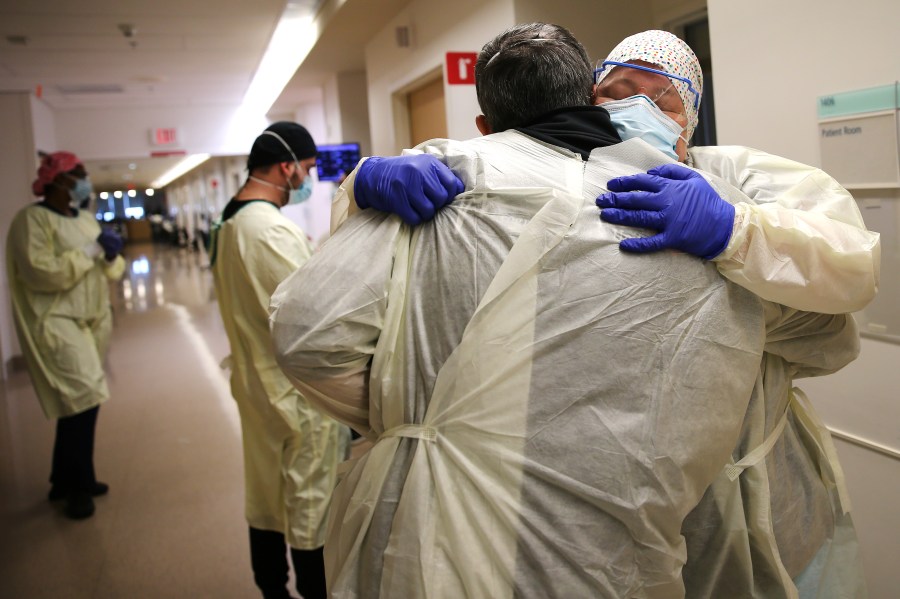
(0, 0), (285, 110)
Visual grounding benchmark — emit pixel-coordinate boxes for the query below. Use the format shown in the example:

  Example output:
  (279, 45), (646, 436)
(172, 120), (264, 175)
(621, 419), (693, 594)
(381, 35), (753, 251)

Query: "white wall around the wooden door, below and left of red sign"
(366, 0), (515, 155)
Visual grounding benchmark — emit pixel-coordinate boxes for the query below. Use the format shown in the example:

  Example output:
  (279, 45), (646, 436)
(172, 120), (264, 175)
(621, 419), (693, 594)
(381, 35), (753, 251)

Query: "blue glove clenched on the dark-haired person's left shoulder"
(353, 154), (465, 225)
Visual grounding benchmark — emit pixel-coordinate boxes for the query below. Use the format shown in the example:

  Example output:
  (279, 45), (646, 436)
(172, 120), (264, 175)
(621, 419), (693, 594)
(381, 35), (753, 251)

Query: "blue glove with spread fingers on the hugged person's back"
(597, 164), (734, 260)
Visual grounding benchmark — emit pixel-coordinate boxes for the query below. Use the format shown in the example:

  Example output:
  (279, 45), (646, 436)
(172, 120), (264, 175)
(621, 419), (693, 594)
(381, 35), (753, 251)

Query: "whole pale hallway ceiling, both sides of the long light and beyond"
(0, 0), (409, 189)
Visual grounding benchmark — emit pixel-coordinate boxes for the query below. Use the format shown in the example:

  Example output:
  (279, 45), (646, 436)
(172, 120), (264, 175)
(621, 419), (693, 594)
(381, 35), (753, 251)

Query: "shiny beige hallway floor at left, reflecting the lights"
(0, 244), (258, 599)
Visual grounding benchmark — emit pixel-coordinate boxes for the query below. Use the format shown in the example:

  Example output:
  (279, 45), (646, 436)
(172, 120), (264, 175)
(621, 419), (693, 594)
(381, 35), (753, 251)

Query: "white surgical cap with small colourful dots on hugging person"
(598, 30), (703, 139)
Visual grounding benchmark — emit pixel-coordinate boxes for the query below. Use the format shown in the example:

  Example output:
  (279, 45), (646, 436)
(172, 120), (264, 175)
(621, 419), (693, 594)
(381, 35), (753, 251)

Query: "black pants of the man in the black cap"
(250, 527), (326, 599)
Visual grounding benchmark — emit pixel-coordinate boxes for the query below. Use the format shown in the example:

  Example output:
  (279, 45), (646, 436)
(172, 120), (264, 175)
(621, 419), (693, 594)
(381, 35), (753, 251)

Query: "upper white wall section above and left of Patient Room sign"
(709, 0), (900, 165)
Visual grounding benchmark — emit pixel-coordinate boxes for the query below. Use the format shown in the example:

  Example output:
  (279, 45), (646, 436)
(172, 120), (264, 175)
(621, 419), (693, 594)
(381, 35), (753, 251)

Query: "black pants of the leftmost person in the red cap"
(50, 406), (100, 493)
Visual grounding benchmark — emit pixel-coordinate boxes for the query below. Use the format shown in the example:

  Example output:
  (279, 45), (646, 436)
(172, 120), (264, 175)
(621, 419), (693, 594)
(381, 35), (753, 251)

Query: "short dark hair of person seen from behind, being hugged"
(475, 23), (593, 132)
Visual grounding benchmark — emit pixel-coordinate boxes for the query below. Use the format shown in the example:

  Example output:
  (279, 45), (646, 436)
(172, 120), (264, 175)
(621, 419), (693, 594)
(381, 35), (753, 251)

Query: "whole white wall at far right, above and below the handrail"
(708, 0), (900, 598)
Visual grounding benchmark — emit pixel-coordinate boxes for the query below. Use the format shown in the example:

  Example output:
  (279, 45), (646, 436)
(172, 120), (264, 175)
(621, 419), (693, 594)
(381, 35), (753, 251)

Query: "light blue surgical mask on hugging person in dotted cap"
(600, 95), (682, 160)
